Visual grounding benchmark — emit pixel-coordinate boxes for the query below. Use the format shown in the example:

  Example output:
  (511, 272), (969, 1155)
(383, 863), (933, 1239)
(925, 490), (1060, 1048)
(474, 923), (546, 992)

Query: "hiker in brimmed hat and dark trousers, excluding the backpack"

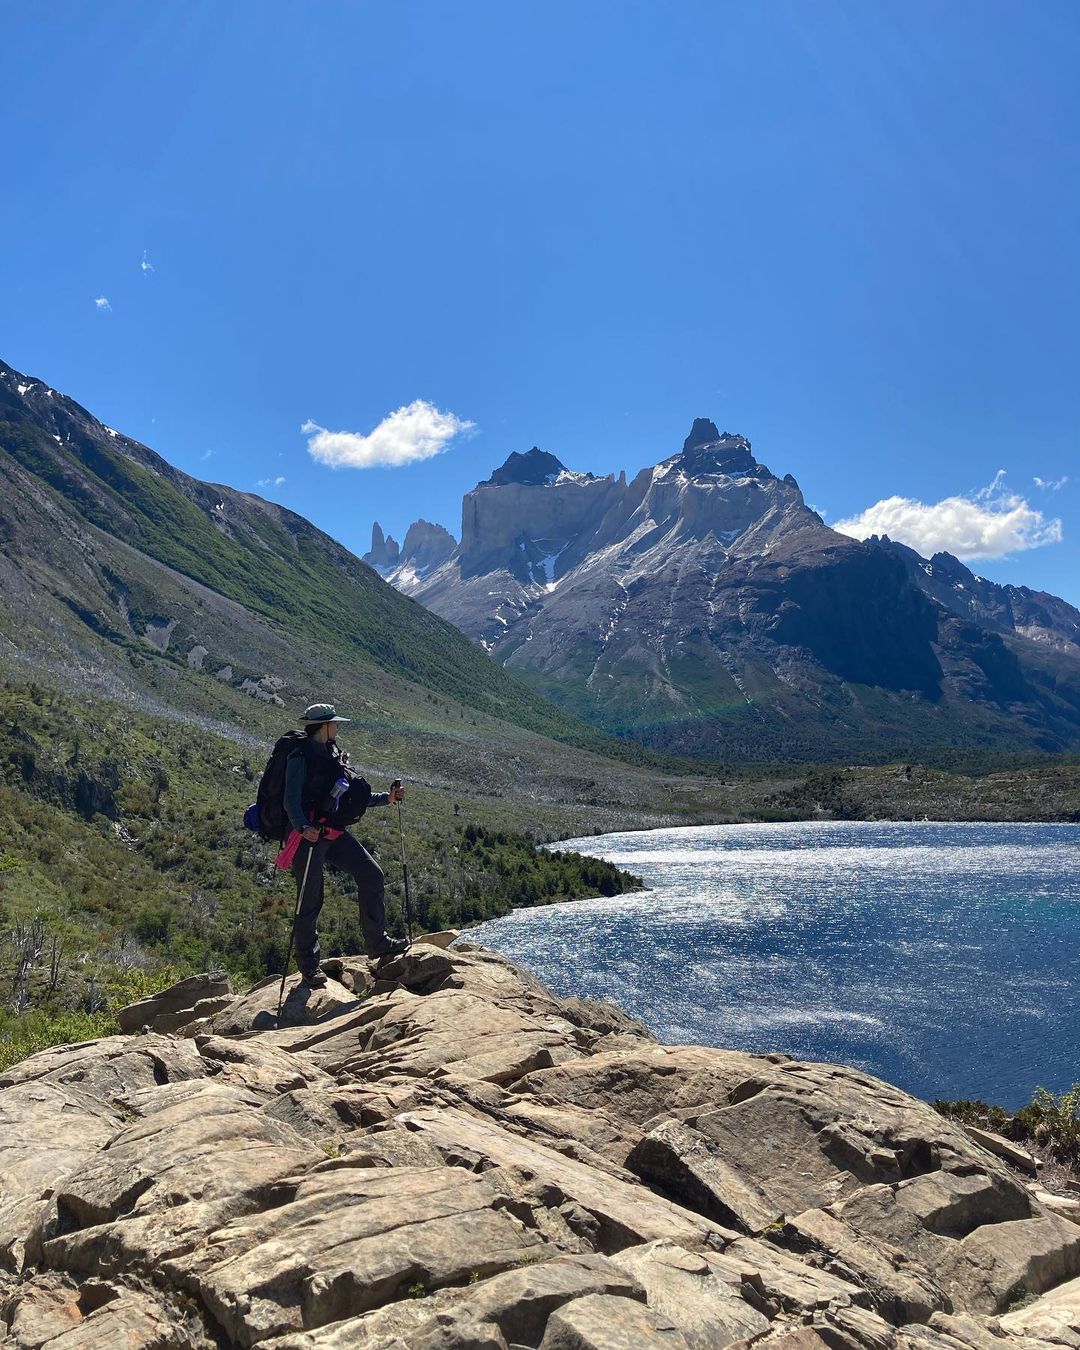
(285, 703), (409, 990)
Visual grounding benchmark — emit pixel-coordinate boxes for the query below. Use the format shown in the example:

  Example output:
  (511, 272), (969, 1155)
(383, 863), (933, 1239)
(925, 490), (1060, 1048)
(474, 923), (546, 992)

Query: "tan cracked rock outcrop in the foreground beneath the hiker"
(0, 945), (1080, 1350)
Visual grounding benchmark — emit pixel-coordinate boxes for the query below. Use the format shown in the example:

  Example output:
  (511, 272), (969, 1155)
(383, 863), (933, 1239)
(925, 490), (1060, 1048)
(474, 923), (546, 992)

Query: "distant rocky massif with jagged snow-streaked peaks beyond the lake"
(366, 419), (1080, 760)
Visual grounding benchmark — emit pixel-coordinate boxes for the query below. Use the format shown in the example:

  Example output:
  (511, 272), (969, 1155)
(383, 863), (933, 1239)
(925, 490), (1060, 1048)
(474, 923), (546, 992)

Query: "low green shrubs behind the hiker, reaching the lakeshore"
(0, 683), (640, 1060)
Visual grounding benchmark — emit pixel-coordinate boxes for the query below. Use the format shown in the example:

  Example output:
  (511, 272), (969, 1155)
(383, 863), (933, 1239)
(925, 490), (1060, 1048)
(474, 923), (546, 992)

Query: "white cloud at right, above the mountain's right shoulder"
(833, 468), (1062, 560)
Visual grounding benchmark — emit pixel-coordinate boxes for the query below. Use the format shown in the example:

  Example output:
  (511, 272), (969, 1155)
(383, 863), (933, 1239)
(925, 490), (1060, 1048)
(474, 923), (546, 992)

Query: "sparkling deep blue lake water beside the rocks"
(468, 822), (1080, 1107)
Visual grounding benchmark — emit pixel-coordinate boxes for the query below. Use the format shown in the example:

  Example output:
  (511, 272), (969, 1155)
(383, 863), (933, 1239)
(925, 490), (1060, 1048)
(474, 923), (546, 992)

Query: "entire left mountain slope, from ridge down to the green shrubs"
(0, 362), (642, 774)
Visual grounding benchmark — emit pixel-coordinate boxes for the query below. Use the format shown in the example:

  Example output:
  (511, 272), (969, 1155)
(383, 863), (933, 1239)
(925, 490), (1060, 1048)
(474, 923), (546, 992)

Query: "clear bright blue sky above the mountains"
(0, 0), (1080, 603)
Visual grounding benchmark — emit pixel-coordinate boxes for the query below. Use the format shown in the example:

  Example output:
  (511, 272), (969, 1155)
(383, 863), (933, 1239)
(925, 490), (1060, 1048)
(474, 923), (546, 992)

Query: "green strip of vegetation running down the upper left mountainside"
(0, 421), (659, 763)
